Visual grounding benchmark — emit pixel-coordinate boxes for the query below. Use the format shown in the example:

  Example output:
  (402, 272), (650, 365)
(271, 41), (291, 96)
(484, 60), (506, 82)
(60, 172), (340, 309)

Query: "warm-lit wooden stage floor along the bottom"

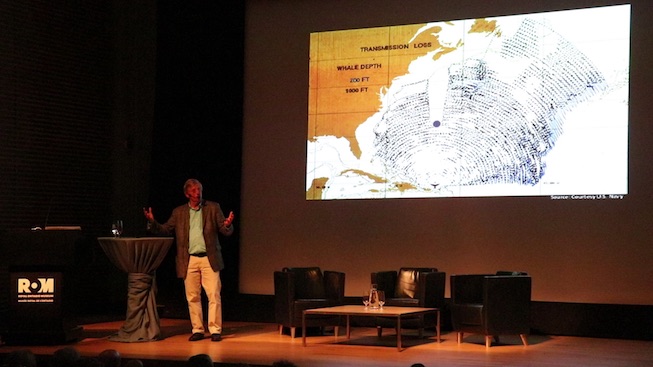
(0, 319), (653, 367)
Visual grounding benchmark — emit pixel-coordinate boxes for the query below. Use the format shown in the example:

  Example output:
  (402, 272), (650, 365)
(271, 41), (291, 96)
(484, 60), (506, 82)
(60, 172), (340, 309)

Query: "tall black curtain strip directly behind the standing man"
(146, 1), (244, 316)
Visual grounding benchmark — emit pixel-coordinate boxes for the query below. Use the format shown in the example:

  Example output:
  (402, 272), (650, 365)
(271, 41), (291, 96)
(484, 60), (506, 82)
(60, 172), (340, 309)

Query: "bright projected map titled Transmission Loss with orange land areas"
(306, 5), (630, 200)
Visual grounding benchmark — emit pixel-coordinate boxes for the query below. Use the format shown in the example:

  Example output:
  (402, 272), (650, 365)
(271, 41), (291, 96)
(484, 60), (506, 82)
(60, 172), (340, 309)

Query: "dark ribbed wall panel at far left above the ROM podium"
(0, 1), (112, 231)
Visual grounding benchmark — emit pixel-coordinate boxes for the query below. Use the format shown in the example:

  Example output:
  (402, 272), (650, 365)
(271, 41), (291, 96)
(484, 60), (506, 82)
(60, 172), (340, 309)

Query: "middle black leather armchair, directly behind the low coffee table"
(370, 267), (446, 336)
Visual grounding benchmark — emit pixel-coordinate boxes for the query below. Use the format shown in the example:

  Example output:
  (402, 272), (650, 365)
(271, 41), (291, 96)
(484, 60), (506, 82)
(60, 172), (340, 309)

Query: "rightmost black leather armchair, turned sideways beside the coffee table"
(450, 271), (531, 348)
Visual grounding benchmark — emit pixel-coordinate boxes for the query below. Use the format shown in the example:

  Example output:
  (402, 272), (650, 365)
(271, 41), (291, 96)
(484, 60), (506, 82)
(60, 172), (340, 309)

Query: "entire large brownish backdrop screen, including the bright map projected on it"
(238, 0), (653, 304)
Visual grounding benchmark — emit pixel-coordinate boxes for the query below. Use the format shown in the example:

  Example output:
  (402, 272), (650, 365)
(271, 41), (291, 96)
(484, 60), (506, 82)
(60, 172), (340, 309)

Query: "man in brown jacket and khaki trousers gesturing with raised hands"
(143, 179), (234, 342)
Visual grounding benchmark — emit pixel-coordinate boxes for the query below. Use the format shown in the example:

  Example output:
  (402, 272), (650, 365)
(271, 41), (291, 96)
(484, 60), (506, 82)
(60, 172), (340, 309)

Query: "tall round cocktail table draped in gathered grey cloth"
(98, 237), (173, 343)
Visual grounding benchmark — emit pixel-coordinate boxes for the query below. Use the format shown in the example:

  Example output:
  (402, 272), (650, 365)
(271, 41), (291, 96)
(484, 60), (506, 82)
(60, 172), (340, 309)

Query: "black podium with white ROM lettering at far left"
(0, 229), (83, 345)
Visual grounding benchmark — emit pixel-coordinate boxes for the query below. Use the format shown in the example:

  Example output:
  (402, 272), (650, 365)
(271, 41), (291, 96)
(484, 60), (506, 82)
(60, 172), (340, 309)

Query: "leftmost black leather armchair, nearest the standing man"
(274, 267), (345, 338)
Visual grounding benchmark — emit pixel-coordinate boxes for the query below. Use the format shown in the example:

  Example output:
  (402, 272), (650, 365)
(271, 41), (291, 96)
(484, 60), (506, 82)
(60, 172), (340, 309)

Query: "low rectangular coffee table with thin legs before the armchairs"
(302, 305), (440, 351)
